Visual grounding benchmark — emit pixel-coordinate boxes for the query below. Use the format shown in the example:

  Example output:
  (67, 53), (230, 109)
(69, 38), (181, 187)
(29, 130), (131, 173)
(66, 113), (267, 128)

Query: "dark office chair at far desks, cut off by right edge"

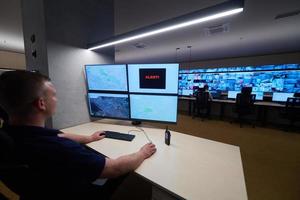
(280, 97), (300, 130)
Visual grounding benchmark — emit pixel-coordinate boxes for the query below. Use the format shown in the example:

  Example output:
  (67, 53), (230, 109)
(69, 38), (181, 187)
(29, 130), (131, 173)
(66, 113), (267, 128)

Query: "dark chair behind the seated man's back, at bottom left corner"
(0, 129), (30, 200)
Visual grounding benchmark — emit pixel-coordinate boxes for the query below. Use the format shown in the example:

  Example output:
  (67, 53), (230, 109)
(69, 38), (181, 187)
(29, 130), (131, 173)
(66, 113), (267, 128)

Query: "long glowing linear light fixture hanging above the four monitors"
(88, 1), (243, 50)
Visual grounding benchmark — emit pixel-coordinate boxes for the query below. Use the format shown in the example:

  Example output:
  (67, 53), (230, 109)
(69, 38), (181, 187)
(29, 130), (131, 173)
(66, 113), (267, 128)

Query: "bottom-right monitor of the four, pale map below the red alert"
(130, 94), (178, 122)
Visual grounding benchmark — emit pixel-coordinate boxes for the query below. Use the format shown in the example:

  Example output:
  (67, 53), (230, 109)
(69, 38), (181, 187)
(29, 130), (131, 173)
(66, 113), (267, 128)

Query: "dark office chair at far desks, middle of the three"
(235, 89), (255, 128)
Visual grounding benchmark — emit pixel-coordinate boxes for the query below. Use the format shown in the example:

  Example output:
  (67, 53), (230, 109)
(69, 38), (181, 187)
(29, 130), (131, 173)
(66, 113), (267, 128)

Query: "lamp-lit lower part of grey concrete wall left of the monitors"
(48, 42), (112, 129)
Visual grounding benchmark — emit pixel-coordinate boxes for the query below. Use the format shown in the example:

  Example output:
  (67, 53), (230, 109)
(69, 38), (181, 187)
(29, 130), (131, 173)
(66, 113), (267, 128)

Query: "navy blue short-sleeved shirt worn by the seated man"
(4, 126), (105, 197)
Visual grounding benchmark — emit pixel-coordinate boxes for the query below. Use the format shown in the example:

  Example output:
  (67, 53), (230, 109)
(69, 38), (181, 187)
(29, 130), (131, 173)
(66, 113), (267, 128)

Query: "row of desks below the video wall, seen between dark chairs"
(178, 97), (285, 125)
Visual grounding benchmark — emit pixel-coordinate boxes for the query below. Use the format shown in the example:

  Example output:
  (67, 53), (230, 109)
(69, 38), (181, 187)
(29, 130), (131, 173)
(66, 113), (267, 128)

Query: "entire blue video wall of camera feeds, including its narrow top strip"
(178, 64), (300, 95)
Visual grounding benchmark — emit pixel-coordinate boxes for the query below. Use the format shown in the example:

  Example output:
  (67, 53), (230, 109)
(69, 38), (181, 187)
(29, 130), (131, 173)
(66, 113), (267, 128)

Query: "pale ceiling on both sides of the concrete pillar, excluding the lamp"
(0, 0), (300, 63)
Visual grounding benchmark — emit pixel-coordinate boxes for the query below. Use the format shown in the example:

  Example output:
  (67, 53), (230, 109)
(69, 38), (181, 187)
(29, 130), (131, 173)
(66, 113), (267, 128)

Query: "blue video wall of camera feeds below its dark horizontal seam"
(179, 70), (300, 95)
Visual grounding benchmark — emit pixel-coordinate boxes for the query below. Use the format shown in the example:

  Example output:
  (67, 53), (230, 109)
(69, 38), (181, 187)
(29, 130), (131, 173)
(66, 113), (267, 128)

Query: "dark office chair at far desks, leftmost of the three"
(193, 90), (211, 121)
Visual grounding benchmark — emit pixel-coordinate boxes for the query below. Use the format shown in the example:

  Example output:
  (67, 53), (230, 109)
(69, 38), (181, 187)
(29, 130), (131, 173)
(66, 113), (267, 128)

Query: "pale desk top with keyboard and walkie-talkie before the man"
(62, 122), (247, 200)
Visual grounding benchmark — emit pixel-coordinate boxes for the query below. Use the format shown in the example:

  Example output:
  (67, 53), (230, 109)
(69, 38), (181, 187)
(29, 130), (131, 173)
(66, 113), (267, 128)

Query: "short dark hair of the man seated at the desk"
(0, 70), (50, 115)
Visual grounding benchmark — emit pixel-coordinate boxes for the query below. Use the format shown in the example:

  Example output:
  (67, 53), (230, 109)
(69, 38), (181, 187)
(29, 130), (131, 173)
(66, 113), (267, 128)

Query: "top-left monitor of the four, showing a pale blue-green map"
(85, 65), (128, 92)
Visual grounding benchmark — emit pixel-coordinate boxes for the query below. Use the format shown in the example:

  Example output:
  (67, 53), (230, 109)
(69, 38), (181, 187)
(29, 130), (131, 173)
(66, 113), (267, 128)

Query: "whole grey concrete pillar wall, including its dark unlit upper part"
(22, 0), (114, 129)
